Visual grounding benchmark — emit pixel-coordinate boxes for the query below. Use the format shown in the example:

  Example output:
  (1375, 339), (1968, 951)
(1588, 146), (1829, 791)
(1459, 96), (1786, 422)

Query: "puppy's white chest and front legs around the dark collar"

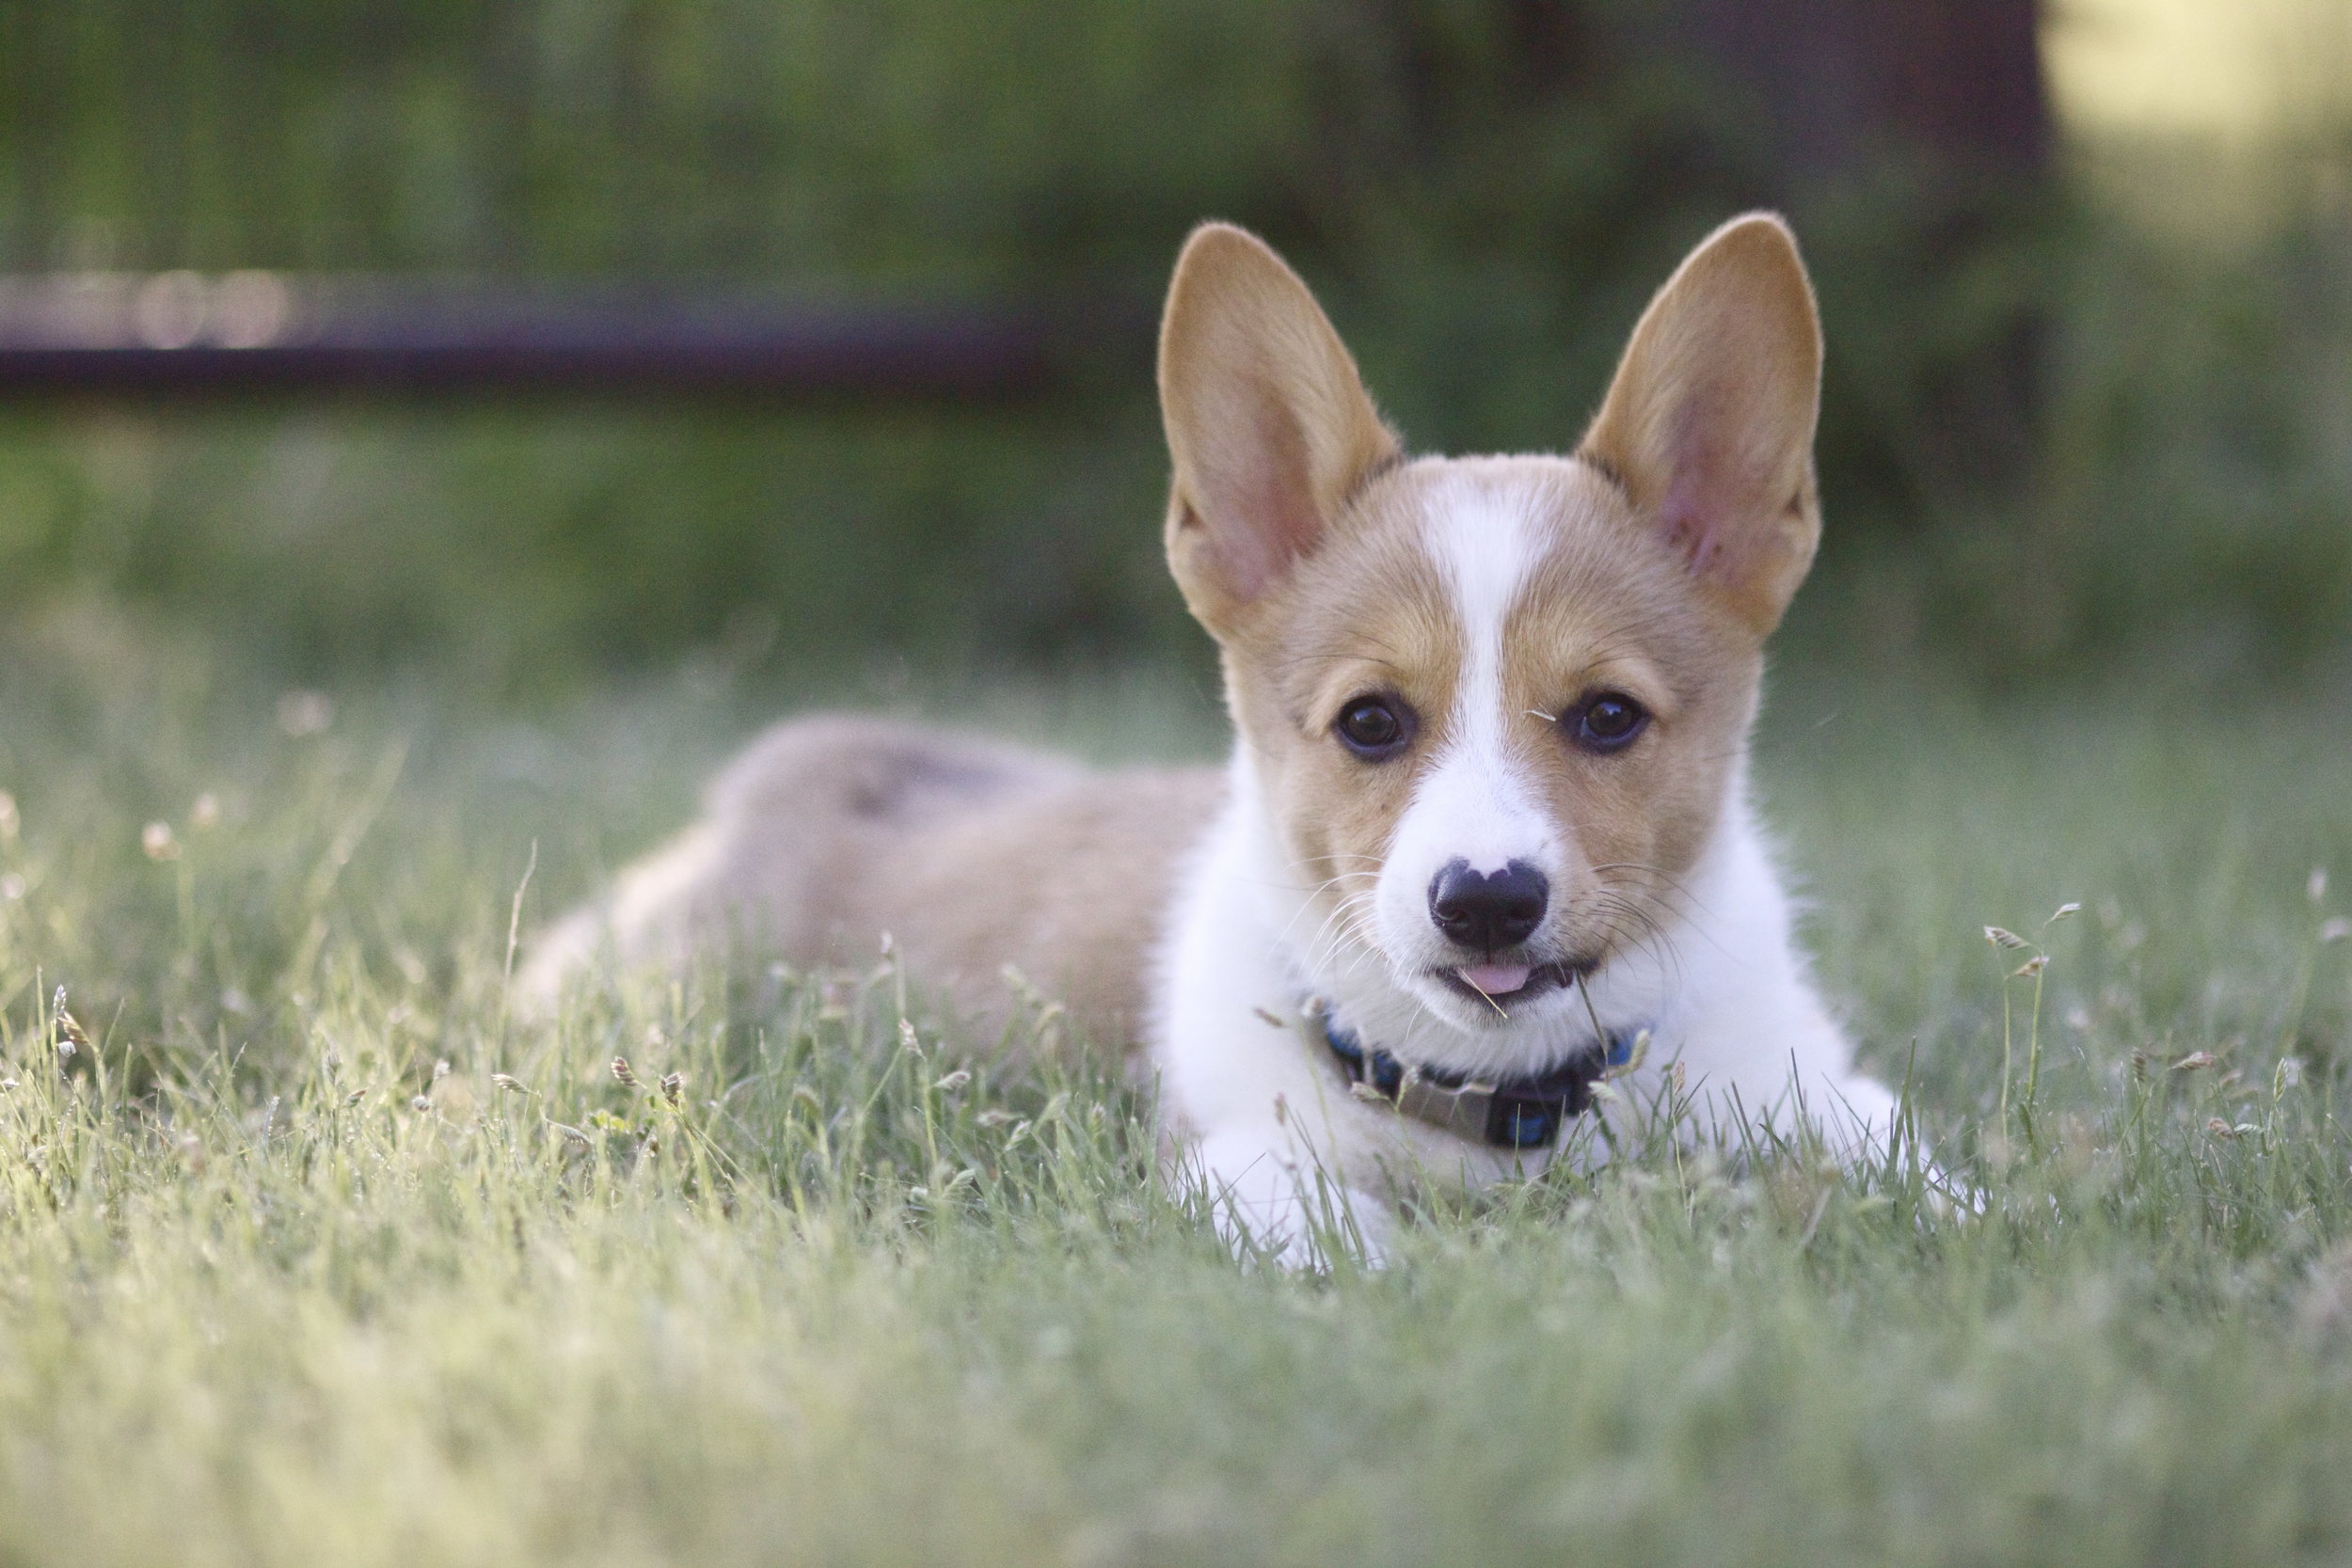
(1152, 752), (1894, 1262)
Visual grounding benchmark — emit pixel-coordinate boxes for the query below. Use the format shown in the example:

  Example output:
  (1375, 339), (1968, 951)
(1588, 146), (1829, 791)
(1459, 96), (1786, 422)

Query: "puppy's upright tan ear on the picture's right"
(1581, 212), (1820, 640)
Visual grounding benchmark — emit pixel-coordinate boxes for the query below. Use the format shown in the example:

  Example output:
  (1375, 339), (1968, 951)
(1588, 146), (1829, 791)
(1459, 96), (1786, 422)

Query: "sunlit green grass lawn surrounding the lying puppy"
(0, 618), (2352, 1563)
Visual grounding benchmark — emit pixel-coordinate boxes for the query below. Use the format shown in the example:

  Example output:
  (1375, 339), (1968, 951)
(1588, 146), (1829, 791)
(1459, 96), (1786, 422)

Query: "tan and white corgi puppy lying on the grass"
(522, 214), (1896, 1262)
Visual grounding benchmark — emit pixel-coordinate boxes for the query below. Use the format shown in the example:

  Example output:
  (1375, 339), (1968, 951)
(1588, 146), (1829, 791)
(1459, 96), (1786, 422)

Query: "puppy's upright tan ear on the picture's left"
(1160, 223), (1397, 637)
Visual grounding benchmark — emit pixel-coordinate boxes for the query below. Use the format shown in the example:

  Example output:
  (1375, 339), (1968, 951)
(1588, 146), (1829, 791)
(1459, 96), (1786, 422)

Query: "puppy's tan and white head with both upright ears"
(1160, 216), (1820, 1032)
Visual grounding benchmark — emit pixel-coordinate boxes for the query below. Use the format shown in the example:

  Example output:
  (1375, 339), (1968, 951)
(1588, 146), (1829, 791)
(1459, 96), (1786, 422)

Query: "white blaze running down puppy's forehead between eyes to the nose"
(1391, 480), (1557, 893)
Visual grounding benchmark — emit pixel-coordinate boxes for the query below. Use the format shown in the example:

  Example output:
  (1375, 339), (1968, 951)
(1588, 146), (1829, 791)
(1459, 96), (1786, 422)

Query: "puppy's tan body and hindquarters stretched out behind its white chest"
(522, 715), (1223, 1051)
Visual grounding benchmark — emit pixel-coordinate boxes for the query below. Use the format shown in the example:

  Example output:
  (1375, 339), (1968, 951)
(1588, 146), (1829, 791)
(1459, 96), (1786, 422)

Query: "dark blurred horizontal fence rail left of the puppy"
(0, 273), (1091, 400)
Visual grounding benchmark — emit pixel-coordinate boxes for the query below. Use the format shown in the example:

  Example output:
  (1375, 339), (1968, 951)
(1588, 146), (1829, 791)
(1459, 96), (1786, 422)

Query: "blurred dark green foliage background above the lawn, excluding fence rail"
(0, 0), (2352, 698)
